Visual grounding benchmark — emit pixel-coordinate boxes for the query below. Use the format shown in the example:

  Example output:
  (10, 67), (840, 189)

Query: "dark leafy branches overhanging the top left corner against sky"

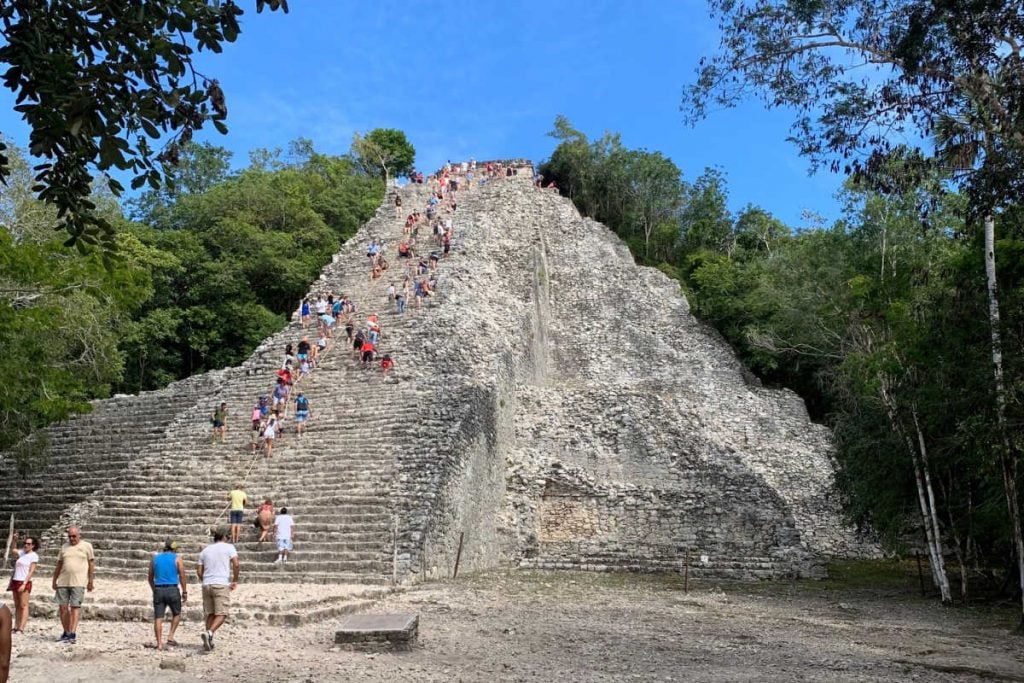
(0, 0), (288, 248)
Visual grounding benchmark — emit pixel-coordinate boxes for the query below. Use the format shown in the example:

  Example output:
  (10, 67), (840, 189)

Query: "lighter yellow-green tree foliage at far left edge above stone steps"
(0, 226), (153, 454)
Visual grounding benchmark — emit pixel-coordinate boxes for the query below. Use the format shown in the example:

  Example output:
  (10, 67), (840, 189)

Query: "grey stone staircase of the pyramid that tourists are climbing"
(0, 180), (468, 583)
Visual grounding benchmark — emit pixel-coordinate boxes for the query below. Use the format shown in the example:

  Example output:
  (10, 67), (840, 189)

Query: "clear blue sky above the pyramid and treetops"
(0, 0), (841, 226)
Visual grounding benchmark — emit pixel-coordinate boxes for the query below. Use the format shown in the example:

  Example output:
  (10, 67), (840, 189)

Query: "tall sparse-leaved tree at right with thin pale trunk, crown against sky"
(683, 0), (1024, 628)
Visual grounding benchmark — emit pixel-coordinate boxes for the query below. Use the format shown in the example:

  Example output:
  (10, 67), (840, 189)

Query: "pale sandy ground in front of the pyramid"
(4, 572), (1024, 683)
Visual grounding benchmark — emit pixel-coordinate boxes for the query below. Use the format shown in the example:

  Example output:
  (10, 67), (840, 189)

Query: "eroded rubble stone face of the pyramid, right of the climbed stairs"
(397, 174), (876, 578)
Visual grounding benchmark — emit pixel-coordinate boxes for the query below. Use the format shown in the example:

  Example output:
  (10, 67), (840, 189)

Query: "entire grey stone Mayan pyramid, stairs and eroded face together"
(0, 166), (870, 584)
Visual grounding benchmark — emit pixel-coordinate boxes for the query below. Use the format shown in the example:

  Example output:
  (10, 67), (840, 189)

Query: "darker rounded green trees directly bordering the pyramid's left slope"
(124, 145), (383, 391)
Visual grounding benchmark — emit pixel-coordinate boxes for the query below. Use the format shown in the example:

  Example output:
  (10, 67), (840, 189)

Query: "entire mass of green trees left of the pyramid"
(0, 135), (384, 462)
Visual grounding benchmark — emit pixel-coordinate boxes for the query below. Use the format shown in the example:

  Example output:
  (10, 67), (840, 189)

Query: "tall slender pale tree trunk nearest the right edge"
(985, 213), (1024, 629)
